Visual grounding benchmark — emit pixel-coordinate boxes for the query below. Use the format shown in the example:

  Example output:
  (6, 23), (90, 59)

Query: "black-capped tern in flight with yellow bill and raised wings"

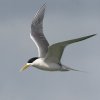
(20, 4), (96, 71)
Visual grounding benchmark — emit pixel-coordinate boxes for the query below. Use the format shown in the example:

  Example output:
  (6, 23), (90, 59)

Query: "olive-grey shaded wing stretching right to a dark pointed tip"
(45, 34), (96, 63)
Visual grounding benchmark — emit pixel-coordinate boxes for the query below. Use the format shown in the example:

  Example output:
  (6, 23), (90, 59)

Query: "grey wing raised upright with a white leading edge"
(30, 4), (49, 57)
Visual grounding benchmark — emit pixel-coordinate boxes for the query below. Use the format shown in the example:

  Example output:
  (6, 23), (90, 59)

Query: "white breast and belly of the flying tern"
(32, 58), (61, 71)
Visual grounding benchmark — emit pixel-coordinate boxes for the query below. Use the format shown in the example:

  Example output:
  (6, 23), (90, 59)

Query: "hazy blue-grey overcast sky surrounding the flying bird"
(0, 0), (100, 100)
